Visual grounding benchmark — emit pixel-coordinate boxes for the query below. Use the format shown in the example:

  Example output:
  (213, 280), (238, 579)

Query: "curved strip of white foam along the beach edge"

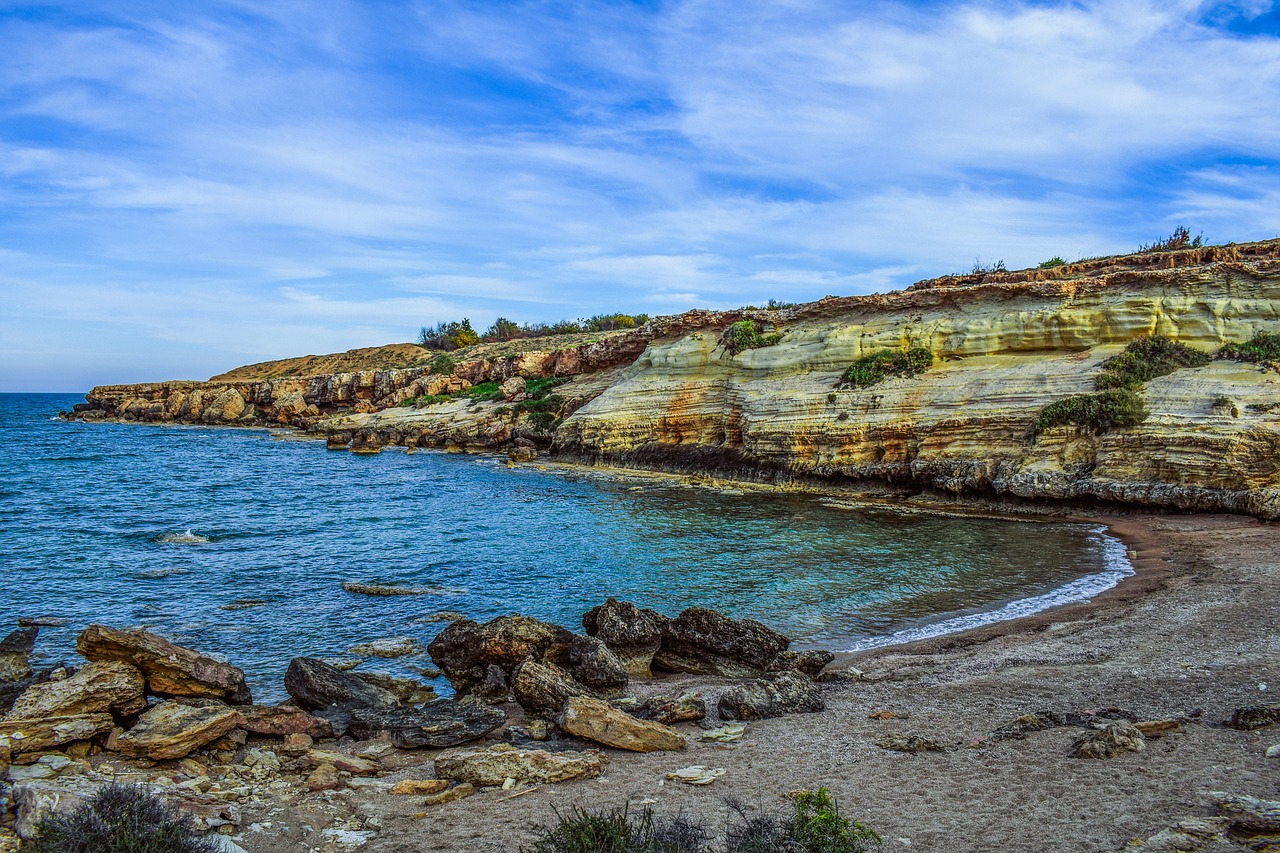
(838, 526), (1134, 652)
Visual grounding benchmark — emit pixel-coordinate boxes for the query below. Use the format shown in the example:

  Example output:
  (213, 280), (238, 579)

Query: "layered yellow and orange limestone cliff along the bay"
(67, 241), (1280, 519)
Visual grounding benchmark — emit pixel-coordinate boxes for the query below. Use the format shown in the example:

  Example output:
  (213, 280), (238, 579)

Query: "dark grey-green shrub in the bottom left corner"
(22, 784), (220, 853)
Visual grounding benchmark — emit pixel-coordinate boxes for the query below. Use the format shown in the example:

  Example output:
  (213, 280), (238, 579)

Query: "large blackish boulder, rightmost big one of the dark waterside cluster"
(653, 607), (791, 678)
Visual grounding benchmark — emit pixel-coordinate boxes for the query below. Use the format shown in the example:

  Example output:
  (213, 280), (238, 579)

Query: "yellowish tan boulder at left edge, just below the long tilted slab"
(6, 661), (147, 720)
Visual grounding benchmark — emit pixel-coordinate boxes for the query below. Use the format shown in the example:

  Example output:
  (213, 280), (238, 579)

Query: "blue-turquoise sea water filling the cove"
(0, 394), (1128, 699)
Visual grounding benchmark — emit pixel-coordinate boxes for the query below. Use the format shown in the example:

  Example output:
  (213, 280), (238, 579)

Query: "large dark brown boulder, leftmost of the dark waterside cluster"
(426, 616), (573, 695)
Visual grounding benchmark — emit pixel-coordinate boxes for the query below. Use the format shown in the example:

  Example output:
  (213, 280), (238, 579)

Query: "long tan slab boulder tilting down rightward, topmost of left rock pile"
(76, 625), (252, 704)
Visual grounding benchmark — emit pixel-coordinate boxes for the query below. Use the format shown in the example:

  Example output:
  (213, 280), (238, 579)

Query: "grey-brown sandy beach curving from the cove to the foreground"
(209, 515), (1280, 853)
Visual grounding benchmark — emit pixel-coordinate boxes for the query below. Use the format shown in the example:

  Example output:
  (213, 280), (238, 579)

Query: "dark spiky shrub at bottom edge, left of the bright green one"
(520, 806), (708, 853)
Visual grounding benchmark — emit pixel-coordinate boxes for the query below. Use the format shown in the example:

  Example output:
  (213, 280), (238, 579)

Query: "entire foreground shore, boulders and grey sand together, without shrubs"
(0, 507), (1280, 853)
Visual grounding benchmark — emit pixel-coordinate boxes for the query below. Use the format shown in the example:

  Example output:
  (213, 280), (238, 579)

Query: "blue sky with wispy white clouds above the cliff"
(0, 0), (1280, 392)
